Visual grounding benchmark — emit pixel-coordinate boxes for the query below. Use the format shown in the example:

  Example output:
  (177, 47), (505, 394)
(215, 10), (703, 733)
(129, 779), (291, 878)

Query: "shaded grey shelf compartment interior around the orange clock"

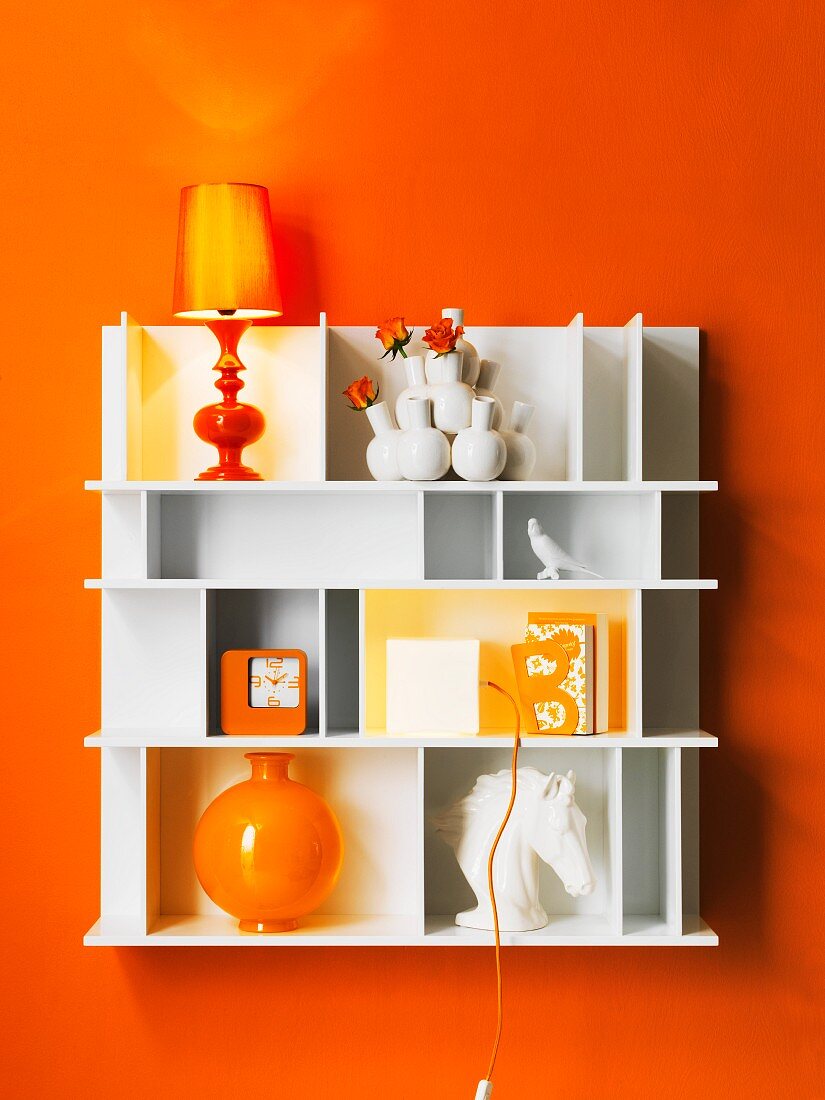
(206, 589), (320, 734)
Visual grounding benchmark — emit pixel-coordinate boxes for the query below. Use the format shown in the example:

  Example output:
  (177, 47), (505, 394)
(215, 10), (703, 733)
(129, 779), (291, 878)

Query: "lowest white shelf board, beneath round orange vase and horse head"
(84, 915), (718, 948)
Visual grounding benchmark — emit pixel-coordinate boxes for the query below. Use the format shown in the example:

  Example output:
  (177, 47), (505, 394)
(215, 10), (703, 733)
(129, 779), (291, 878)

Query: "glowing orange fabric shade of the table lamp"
(173, 184), (283, 321)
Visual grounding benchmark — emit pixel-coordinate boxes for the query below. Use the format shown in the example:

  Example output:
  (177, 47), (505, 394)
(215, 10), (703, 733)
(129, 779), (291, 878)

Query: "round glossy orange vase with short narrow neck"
(194, 752), (343, 932)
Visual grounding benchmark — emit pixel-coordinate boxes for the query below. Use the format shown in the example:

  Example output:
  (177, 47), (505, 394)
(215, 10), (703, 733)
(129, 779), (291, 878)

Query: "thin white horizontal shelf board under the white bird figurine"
(84, 576), (719, 592)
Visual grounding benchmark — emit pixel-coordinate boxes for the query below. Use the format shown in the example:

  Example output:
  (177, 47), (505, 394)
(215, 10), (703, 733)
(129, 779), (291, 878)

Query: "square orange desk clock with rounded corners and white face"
(221, 649), (307, 736)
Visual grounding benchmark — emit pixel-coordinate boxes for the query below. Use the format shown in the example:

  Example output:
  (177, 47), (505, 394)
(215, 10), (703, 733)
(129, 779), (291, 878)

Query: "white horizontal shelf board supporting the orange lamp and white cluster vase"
(86, 481), (719, 493)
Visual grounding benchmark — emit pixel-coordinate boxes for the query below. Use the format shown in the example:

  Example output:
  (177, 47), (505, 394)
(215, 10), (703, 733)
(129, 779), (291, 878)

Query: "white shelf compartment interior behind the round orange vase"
(145, 746), (420, 943)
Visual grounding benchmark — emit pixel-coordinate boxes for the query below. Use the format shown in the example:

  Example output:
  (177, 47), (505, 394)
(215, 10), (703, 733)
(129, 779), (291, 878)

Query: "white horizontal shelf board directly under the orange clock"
(84, 729), (718, 749)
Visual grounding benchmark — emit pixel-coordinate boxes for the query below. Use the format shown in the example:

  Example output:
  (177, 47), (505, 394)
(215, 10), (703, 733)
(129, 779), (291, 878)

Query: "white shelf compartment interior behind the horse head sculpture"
(424, 747), (622, 943)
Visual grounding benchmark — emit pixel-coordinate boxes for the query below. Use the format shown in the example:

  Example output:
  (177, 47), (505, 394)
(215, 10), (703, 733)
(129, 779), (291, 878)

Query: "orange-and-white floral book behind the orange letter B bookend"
(525, 612), (609, 736)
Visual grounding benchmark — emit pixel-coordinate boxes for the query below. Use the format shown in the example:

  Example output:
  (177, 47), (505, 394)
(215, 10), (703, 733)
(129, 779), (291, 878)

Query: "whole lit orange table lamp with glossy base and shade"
(173, 184), (283, 481)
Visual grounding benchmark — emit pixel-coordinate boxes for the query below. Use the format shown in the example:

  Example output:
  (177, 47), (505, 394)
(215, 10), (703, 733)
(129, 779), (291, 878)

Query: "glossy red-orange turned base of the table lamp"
(193, 317), (266, 481)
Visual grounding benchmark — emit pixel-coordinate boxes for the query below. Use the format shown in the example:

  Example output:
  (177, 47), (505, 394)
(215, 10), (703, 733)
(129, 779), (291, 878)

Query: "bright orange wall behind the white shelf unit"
(0, 0), (825, 1100)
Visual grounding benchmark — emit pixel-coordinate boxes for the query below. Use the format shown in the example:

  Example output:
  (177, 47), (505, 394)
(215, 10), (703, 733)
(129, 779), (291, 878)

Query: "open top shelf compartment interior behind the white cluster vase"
(327, 318), (581, 481)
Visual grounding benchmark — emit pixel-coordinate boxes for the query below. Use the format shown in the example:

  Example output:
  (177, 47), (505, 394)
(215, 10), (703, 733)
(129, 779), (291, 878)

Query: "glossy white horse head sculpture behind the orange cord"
(432, 768), (596, 932)
